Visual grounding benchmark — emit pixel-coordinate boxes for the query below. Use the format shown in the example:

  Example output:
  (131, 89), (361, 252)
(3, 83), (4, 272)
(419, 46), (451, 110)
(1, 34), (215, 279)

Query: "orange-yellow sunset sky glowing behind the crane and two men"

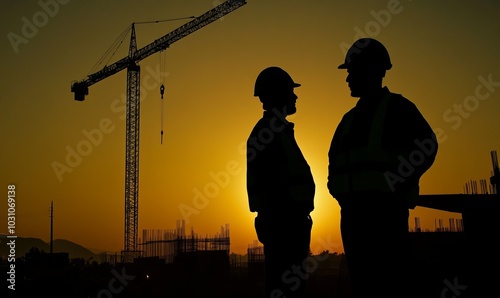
(0, 0), (500, 253)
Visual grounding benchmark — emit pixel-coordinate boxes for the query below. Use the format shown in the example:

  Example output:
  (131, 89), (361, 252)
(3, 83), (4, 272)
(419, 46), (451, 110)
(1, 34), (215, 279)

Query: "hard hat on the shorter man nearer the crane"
(253, 66), (300, 96)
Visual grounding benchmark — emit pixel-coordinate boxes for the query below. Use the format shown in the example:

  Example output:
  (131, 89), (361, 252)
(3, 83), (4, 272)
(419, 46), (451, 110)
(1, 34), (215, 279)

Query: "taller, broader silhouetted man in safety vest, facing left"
(328, 38), (438, 297)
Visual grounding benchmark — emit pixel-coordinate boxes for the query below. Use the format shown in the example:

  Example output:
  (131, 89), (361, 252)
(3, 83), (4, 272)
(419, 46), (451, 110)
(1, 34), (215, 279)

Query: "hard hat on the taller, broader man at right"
(338, 38), (392, 70)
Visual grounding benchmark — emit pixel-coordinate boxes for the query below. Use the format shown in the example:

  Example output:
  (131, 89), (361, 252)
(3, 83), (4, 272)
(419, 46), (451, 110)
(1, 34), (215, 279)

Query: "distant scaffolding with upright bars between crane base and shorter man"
(139, 220), (230, 263)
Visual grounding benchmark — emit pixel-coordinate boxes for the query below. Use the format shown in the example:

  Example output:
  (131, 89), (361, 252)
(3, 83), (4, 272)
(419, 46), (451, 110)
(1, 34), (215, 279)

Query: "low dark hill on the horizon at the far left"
(0, 235), (97, 259)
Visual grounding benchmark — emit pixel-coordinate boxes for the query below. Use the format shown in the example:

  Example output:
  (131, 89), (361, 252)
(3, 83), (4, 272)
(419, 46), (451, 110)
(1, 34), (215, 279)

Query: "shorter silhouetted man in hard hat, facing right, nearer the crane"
(247, 66), (315, 298)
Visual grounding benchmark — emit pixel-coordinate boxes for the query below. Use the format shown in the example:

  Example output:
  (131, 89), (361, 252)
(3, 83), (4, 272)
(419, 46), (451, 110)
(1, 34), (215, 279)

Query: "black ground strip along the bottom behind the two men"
(0, 233), (500, 298)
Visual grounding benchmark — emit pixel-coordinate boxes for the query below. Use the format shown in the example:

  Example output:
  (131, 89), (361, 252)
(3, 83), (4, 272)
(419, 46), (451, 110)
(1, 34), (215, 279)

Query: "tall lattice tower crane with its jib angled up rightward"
(71, 0), (246, 258)
